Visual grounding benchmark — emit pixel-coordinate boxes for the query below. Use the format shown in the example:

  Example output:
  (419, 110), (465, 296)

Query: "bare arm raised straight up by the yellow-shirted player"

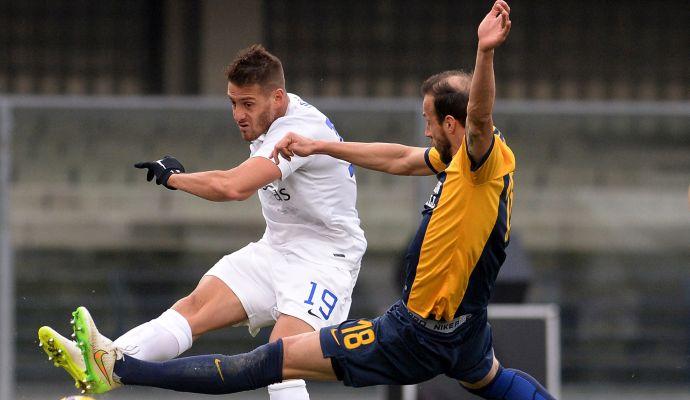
(465, 0), (510, 162)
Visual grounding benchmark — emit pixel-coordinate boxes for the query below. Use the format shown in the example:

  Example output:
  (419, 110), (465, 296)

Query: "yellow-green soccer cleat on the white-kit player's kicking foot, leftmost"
(38, 326), (87, 390)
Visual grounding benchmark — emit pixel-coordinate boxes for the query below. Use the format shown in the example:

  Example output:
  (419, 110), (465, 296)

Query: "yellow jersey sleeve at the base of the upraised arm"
(458, 128), (515, 185)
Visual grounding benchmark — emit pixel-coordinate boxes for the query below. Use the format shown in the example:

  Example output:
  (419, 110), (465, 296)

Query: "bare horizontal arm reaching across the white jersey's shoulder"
(271, 132), (433, 175)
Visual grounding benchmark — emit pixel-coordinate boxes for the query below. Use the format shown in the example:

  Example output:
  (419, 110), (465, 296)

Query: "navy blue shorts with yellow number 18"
(320, 301), (493, 387)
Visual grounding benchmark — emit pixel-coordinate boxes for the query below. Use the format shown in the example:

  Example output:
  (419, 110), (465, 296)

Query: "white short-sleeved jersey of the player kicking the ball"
(250, 93), (367, 269)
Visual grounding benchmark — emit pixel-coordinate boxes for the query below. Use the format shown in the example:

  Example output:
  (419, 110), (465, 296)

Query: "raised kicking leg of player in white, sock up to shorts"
(115, 243), (280, 361)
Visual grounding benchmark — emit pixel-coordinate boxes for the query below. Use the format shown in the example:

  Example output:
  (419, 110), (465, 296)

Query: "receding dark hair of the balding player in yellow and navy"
(421, 70), (472, 126)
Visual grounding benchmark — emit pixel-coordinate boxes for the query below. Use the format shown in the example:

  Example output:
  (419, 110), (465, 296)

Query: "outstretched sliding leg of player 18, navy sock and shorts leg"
(84, 304), (422, 394)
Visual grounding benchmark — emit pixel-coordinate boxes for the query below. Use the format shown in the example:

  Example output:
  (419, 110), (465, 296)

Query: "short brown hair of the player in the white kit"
(225, 44), (285, 90)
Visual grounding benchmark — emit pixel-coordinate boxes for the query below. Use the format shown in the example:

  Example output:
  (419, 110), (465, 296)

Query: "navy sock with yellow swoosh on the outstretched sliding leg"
(113, 340), (283, 394)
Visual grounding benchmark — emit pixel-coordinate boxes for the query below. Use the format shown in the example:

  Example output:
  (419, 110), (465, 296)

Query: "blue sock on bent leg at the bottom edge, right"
(467, 367), (556, 400)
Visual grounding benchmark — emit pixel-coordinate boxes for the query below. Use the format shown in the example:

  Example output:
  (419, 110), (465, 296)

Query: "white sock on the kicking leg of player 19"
(114, 309), (192, 361)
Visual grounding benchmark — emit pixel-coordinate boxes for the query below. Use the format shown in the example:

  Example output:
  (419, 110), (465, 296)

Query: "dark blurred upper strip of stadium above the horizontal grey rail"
(0, 0), (690, 100)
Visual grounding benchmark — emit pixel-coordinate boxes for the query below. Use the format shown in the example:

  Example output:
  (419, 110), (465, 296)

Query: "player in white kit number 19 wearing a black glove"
(39, 45), (366, 400)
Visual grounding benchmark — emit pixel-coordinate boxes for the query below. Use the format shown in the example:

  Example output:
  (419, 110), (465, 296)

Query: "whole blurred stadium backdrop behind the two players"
(0, 0), (690, 398)
